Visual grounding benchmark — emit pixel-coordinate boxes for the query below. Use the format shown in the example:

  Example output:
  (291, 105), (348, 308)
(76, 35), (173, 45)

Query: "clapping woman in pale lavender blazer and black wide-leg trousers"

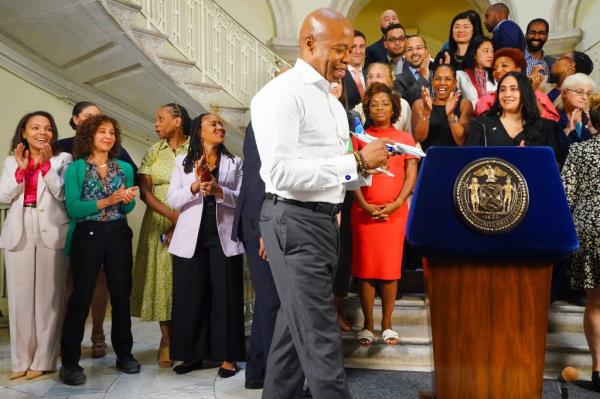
(167, 114), (245, 378)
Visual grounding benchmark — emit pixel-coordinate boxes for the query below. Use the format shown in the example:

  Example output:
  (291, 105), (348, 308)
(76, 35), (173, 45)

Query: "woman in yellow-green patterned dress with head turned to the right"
(131, 103), (191, 368)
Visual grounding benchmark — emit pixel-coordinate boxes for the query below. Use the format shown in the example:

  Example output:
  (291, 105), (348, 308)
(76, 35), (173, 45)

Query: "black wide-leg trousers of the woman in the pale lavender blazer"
(170, 239), (245, 362)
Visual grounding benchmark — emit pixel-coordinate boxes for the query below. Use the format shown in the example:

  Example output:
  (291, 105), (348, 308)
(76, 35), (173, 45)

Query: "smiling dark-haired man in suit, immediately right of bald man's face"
(344, 30), (367, 109)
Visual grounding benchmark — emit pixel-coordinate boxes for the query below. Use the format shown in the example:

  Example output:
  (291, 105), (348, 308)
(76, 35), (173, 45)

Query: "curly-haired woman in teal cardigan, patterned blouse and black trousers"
(60, 115), (140, 385)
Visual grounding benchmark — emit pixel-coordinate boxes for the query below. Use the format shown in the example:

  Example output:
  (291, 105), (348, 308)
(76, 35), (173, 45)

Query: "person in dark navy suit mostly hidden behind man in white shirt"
(231, 123), (279, 389)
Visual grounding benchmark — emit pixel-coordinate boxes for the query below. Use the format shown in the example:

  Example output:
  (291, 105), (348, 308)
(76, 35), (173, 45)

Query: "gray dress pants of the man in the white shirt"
(260, 199), (351, 399)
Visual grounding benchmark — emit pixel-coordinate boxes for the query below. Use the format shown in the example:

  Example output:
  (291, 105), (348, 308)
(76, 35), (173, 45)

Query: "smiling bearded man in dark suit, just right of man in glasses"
(394, 35), (432, 107)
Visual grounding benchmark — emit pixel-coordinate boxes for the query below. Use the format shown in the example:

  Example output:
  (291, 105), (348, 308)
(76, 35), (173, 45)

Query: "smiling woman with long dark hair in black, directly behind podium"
(465, 72), (564, 164)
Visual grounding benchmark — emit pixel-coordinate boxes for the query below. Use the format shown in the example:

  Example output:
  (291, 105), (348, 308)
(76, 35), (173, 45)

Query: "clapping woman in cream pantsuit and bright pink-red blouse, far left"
(0, 111), (71, 379)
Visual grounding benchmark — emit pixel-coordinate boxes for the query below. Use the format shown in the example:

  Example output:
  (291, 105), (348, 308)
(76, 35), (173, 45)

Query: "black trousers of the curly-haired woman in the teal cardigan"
(60, 220), (133, 367)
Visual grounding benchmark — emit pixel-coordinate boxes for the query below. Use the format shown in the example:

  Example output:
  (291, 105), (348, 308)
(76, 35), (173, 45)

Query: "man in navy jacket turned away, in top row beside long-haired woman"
(484, 3), (526, 51)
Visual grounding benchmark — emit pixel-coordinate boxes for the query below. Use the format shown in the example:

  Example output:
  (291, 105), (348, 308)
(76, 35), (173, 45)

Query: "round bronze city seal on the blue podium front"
(453, 158), (529, 235)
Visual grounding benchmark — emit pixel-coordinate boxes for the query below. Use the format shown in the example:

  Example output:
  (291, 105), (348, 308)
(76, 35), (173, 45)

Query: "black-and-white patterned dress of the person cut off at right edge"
(562, 136), (600, 288)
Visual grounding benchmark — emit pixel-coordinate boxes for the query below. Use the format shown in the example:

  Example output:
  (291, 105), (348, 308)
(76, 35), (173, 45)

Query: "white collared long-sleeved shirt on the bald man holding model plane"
(250, 59), (358, 204)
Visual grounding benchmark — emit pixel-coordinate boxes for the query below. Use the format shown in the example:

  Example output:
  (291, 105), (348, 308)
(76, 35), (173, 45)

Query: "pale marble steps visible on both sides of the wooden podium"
(342, 294), (591, 378)
